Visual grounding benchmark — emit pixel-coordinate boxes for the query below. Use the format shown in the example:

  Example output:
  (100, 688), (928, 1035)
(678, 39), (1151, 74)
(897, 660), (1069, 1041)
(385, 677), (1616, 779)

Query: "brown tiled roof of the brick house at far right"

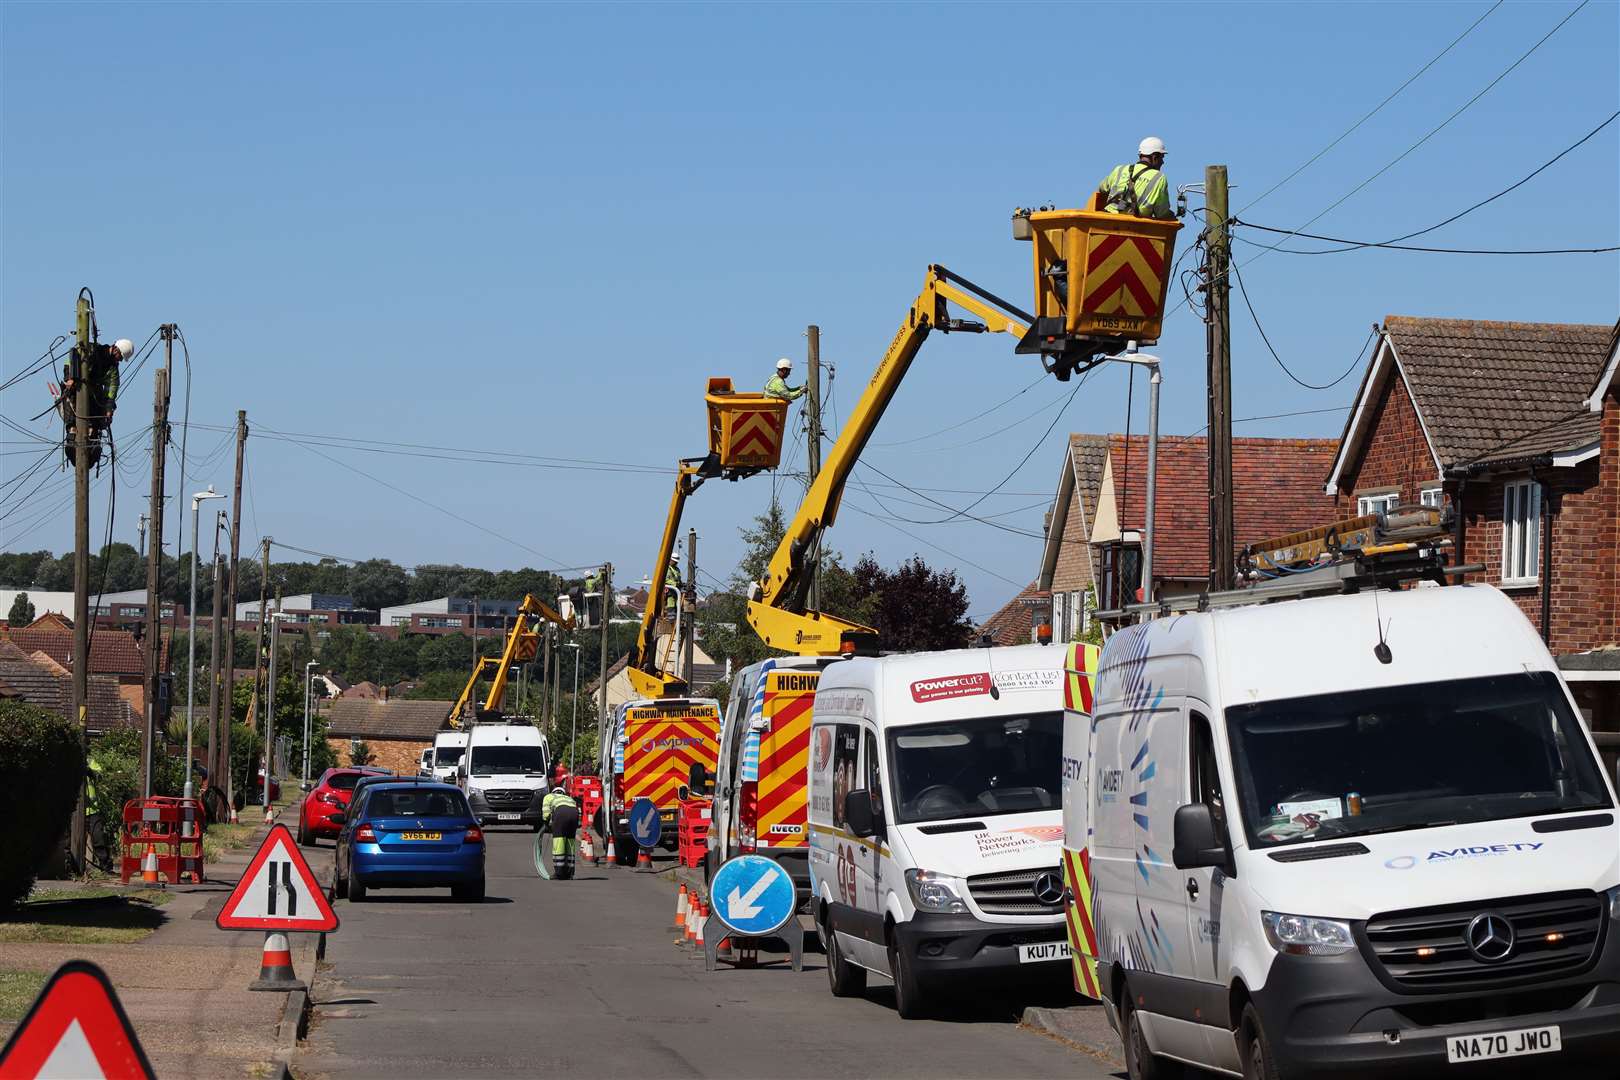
(1383, 316), (1615, 470)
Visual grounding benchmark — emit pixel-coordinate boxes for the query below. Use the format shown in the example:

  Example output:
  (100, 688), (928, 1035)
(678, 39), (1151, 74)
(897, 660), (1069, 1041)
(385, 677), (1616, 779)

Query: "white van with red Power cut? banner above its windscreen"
(808, 644), (1069, 1018)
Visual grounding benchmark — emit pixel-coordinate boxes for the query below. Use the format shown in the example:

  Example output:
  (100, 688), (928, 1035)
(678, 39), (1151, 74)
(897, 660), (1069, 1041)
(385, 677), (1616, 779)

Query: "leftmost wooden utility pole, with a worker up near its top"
(68, 288), (96, 873)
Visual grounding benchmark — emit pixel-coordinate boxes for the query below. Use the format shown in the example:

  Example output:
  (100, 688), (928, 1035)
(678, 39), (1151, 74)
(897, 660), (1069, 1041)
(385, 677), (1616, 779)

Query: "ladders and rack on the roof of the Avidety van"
(1095, 507), (1486, 623)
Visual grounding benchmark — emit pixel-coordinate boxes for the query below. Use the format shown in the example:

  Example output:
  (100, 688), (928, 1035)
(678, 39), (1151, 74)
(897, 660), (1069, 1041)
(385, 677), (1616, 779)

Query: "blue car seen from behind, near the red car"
(335, 780), (484, 904)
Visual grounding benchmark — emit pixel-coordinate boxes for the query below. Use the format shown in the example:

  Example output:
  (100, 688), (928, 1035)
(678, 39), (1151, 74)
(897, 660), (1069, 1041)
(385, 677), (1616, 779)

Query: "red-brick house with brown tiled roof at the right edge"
(1327, 316), (1620, 732)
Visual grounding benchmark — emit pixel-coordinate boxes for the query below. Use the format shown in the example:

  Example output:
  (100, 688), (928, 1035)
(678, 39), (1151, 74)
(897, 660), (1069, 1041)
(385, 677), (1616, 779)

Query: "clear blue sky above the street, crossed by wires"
(0, 0), (1620, 615)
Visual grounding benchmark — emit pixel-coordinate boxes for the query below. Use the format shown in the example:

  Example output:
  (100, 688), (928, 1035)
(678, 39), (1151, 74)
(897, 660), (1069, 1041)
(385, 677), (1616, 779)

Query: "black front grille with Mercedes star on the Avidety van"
(1361, 892), (1604, 993)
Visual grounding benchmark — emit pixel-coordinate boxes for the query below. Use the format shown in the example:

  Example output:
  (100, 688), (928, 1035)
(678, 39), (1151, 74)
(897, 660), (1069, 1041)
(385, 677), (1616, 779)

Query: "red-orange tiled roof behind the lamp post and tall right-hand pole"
(1108, 436), (1338, 580)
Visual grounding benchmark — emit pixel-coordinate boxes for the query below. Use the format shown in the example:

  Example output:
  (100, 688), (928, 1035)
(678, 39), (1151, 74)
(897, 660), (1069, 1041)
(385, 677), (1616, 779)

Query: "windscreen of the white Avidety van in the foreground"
(1226, 672), (1609, 847)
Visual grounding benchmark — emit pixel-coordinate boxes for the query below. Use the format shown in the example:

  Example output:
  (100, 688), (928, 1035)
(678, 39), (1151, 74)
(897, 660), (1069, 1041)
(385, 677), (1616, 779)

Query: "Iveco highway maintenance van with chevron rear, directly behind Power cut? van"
(703, 656), (838, 904)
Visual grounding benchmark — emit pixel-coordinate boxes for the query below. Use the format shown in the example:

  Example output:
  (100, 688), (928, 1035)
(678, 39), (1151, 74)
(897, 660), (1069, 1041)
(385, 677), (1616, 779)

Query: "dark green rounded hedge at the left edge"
(0, 698), (84, 910)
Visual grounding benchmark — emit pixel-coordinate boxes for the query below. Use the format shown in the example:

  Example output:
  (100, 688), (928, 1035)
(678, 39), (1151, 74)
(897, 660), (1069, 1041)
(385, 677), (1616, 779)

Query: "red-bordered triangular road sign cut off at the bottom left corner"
(0, 960), (156, 1080)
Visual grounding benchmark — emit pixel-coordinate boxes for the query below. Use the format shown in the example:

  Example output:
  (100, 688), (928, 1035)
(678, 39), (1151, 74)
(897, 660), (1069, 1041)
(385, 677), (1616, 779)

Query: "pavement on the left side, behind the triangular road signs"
(0, 803), (330, 1080)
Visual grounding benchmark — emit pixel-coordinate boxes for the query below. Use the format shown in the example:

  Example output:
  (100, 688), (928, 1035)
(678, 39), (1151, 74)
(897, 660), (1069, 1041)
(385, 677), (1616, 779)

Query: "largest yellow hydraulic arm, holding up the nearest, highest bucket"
(748, 266), (1034, 656)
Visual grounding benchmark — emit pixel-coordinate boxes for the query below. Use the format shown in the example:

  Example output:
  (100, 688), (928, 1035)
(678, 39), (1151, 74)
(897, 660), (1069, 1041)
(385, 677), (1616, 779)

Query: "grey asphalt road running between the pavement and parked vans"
(293, 832), (1116, 1080)
